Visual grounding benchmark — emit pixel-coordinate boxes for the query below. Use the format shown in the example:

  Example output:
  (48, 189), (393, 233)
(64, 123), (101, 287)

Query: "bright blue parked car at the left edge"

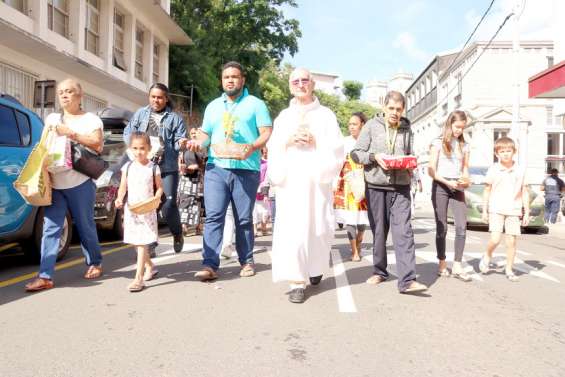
(0, 94), (73, 262)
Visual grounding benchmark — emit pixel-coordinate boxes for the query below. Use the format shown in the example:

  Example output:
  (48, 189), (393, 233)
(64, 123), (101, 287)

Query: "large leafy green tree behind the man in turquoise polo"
(169, 0), (301, 108)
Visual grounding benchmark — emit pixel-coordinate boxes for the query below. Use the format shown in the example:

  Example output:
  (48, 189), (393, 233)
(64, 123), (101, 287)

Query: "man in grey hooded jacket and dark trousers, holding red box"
(351, 91), (428, 293)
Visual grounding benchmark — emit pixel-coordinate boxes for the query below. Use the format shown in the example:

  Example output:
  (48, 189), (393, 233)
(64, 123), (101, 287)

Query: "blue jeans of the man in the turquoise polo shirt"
(202, 164), (259, 271)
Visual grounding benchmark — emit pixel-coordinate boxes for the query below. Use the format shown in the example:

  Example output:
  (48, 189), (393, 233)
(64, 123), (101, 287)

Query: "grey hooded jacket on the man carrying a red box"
(351, 117), (414, 190)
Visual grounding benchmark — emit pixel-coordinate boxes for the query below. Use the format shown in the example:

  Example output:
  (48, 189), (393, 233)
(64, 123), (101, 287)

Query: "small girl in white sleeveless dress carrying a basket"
(116, 132), (163, 292)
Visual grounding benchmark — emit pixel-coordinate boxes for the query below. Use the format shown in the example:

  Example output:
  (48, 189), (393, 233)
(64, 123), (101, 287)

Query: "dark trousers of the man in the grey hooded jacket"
(365, 186), (416, 291)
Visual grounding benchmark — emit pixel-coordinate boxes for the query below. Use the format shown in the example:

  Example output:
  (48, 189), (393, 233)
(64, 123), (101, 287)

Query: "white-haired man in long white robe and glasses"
(267, 68), (343, 303)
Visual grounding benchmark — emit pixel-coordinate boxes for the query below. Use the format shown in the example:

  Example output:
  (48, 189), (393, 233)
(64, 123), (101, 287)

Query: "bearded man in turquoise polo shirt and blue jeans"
(188, 62), (272, 281)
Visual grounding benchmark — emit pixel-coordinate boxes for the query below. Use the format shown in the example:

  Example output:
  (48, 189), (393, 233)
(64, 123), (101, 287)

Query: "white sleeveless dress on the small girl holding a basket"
(122, 161), (161, 245)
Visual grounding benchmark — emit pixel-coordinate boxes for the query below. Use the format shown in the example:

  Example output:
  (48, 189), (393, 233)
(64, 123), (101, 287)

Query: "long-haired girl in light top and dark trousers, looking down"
(428, 110), (471, 282)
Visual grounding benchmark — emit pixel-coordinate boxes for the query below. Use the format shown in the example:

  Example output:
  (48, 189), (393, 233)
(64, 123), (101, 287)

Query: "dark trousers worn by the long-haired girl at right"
(432, 181), (467, 262)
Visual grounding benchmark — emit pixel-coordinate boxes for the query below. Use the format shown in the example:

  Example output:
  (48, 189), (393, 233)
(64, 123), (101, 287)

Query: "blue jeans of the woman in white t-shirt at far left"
(39, 179), (102, 279)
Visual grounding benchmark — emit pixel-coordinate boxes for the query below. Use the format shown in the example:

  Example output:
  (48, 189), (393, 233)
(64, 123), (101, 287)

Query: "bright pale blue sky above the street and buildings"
(284, 0), (552, 88)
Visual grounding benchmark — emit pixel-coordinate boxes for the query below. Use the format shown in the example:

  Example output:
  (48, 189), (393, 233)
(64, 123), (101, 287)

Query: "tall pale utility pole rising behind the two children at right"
(510, 0), (528, 167)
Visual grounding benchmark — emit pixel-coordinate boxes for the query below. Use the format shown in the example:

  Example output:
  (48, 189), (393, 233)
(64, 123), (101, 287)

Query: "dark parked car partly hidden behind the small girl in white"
(94, 107), (133, 238)
